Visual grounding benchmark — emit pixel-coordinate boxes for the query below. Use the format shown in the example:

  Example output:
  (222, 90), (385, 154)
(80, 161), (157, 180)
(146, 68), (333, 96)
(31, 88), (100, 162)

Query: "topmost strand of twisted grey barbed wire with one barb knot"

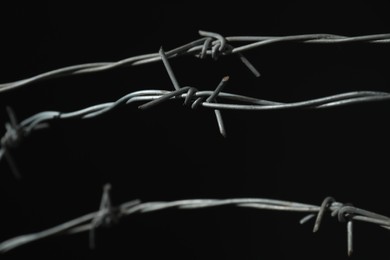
(0, 31), (390, 93)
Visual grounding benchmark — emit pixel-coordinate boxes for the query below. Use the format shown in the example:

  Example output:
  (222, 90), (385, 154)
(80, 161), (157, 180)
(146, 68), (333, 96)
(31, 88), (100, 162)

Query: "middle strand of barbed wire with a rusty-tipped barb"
(0, 45), (390, 179)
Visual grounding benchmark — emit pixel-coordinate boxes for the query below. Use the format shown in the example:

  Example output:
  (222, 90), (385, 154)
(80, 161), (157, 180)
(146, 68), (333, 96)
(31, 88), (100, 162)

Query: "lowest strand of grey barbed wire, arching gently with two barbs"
(0, 184), (390, 255)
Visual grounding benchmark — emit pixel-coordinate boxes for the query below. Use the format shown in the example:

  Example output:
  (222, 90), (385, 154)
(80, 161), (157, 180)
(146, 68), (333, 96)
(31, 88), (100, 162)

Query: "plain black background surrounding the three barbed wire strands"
(0, 1), (390, 259)
